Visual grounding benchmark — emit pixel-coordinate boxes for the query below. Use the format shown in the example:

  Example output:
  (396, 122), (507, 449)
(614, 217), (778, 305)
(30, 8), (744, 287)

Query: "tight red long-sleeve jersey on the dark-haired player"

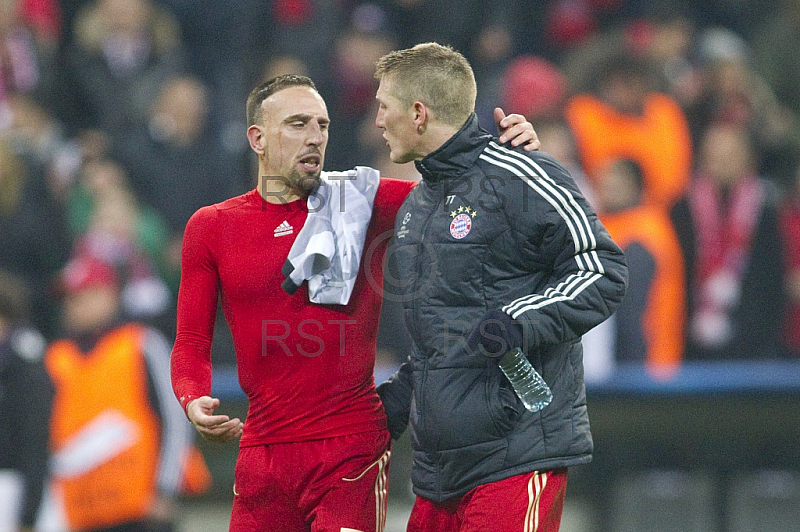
(172, 179), (415, 447)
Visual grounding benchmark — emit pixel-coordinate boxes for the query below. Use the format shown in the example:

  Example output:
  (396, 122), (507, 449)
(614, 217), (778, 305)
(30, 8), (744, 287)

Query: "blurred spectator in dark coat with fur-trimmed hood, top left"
(58, 0), (187, 138)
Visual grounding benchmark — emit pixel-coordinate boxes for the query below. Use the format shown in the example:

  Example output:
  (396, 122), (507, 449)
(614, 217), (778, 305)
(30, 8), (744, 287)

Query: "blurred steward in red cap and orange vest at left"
(41, 257), (210, 532)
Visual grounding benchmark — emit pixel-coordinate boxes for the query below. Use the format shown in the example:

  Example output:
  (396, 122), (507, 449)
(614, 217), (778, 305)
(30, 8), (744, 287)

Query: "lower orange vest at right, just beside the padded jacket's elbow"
(600, 206), (686, 376)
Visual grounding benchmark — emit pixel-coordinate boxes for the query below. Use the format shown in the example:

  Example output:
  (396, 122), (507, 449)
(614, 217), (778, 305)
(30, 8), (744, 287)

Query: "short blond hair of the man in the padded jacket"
(375, 42), (478, 128)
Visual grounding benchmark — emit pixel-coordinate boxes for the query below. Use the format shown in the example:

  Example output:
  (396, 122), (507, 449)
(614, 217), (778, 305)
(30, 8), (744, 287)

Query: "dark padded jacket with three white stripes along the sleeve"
(378, 114), (627, 501)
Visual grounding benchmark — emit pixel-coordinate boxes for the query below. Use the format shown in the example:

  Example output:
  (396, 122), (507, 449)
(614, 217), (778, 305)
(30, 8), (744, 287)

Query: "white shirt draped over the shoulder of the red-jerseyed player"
(282, 166), (380, 305)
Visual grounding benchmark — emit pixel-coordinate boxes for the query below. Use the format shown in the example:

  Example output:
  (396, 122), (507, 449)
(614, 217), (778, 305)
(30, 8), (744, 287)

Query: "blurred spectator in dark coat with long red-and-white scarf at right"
(672, 124), (785, 360)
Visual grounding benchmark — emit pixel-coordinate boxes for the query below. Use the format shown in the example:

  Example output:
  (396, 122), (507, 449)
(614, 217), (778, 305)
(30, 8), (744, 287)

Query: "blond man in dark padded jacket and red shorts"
(376, 43), (627, 532)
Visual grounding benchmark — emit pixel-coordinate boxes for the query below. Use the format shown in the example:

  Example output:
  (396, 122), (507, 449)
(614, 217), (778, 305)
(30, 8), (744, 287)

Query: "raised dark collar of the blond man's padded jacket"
(414, 113), (492, 181)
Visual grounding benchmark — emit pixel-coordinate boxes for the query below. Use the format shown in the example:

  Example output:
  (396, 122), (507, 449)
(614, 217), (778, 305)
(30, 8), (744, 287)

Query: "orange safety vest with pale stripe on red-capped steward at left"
(45, 325), (160, 530)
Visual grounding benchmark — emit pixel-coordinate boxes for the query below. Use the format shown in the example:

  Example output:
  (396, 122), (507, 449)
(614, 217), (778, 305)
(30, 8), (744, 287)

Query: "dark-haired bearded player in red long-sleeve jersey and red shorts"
(172, 75), (538, 532)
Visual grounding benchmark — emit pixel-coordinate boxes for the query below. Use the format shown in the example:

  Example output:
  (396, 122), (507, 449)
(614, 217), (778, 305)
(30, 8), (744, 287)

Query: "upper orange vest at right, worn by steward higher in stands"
(565, 93), (692, 206)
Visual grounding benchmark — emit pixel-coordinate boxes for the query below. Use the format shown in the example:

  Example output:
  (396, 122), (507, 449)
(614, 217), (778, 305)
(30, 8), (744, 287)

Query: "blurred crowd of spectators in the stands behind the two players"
(0, 0), (800, 380)
